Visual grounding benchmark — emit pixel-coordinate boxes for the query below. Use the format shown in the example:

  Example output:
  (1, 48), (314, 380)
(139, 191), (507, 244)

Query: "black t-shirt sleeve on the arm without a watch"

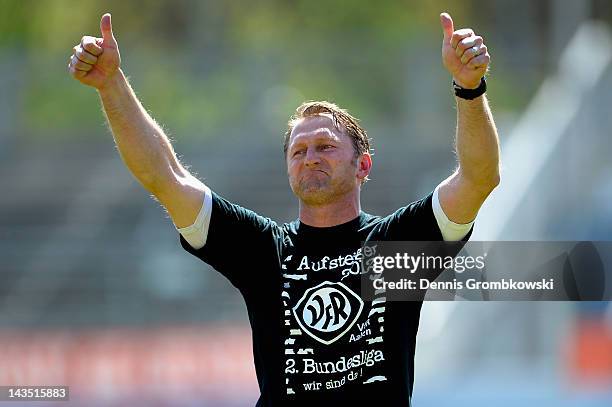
(179, 192), (280, 290)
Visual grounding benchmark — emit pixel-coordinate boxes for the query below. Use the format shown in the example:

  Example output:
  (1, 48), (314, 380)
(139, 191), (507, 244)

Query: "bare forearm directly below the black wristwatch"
(456, 95), (499, 190)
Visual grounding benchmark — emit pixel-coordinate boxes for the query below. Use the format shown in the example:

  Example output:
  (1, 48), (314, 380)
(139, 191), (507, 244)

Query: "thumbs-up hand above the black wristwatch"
(440, 13), (491, 89)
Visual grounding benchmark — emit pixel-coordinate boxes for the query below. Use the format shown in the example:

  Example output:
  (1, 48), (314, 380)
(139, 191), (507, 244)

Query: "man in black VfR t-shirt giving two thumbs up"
(68, 13), (499, 406)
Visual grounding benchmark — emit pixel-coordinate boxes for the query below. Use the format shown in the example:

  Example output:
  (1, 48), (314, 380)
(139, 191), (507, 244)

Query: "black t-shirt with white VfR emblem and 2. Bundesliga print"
(180, 193), (471, 407)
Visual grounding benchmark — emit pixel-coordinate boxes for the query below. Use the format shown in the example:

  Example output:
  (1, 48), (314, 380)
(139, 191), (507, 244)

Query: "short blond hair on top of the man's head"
(283, 101), (370, 157)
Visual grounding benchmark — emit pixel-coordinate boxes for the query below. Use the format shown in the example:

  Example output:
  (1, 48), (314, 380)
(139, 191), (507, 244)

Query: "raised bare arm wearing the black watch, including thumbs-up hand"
(439, 13), (500, 223)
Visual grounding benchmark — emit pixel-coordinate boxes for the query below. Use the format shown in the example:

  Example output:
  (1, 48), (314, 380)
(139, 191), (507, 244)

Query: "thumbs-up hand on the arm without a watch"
(68, 13), (121, 89)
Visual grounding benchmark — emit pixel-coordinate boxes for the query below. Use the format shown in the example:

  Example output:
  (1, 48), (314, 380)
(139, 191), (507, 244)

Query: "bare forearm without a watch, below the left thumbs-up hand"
(98, 70), (181, 192)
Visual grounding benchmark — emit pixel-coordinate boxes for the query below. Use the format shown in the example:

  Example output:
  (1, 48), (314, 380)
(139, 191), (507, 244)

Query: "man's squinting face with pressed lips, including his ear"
(287, 114), (370, 205)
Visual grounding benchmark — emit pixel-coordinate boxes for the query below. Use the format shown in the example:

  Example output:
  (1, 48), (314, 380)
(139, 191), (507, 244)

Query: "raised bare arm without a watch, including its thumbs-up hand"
(68, 14), (205, 228)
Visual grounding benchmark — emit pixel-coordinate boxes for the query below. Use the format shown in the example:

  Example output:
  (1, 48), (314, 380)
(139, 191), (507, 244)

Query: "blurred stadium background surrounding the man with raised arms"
(0, 0), (612, 407)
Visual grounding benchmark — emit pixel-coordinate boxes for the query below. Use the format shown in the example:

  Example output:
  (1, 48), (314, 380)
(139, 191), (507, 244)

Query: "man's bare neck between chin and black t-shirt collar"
(300, 196), (361, 228)
